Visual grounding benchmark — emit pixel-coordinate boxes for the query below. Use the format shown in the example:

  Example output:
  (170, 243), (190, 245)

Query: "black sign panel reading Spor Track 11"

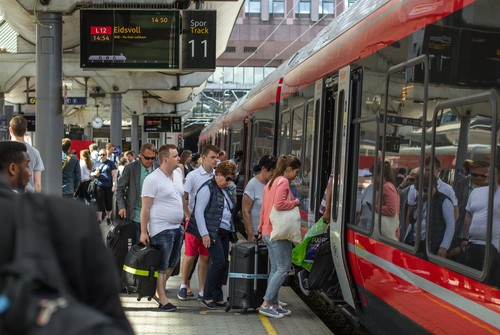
(182, 10), (217, 71)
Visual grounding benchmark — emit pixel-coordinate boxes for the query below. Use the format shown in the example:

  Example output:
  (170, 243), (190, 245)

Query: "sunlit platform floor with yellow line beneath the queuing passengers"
(101, 224), (333, 335)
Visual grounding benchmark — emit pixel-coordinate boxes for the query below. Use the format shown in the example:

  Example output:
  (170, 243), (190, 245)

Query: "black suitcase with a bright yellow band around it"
(122, 243), (161, 300)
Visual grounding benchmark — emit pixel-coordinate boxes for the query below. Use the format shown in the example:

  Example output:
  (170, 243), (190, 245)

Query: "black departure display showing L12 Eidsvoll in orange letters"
(80, 9), (180, 70)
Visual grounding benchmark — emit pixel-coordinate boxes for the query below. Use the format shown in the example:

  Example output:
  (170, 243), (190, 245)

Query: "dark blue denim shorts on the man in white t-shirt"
(151, 228), (184, 273)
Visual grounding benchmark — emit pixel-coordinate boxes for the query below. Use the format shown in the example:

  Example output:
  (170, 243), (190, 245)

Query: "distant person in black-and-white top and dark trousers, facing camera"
(90, 149), (118, 225)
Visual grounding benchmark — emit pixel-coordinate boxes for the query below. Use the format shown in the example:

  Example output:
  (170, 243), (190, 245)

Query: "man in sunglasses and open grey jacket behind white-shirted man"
(116, 142), (158, 242)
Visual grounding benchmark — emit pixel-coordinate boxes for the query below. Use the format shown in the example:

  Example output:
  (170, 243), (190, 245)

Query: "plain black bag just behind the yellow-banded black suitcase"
(106, 218), (135, 274)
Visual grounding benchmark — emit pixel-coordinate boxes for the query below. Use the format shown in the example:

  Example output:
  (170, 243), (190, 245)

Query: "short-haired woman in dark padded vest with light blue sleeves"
(187, 161), (236, 309)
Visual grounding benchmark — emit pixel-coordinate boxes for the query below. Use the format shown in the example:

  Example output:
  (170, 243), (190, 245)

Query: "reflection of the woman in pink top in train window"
(375, 161), (400, 241)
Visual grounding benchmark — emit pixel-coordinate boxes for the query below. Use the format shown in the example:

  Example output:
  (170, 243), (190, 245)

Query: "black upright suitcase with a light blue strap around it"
(226, 242), (269, 313)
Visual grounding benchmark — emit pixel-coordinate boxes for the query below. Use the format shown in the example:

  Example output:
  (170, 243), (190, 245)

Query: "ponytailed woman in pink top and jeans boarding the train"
(258, 155), (300, 318)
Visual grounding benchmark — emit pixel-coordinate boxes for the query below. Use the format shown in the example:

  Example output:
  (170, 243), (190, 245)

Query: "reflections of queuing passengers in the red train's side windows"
(356, 157), (500, 285)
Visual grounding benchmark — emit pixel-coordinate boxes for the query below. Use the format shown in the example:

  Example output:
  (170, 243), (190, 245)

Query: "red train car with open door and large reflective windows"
(200, 0), (500, 334)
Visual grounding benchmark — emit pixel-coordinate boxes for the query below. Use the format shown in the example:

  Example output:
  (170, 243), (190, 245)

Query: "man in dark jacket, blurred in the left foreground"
(0, 142), (133, 335)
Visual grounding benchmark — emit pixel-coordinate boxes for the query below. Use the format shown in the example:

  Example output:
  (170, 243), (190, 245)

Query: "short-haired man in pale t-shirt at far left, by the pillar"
(9, 115), (45, 193)
